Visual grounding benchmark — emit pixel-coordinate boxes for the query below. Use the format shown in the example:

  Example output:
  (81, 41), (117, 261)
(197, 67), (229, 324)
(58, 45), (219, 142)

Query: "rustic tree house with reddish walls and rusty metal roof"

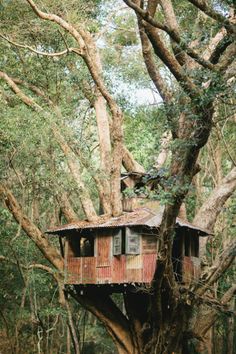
(47, 208), (208, 287)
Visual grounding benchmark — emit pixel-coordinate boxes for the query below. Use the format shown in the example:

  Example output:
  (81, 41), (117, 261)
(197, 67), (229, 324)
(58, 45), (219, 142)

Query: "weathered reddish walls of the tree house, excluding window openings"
(65, 230), (200, 284)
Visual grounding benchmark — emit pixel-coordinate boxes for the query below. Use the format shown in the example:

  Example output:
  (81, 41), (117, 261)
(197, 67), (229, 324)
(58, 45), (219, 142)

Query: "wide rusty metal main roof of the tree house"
(46, 207), (210, 236)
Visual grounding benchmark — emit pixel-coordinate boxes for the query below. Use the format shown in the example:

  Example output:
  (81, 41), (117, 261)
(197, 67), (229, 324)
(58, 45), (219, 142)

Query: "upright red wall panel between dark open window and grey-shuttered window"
(97, 236), (112, 267)
